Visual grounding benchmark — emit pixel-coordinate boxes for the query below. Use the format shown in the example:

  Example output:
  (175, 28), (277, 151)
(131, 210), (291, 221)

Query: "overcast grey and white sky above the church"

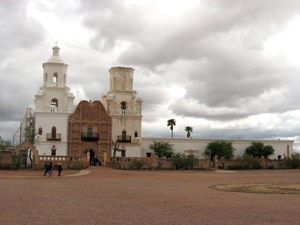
(0, 0), (300, 150)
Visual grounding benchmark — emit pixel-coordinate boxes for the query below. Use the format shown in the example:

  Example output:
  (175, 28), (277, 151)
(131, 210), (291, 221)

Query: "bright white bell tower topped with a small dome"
(35, 46), (74, 156)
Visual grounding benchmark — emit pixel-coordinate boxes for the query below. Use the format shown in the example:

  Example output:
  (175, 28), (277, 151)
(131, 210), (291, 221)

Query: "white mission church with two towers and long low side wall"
(29, 46), (294, 160)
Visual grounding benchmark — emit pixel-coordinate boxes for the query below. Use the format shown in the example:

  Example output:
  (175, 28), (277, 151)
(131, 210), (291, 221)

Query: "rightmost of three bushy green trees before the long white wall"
(245, 141), (275, 159)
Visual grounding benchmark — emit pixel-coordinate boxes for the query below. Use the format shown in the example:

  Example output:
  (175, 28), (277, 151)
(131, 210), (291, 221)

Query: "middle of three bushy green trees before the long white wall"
(204, 140), (235, 160)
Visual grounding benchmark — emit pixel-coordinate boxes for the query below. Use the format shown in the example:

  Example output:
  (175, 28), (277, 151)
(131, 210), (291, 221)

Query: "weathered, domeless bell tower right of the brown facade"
(102, 67), (142, 157)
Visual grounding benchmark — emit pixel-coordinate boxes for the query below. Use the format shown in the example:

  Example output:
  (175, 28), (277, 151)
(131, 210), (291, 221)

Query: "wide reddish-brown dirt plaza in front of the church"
(0, 167), (300, 225)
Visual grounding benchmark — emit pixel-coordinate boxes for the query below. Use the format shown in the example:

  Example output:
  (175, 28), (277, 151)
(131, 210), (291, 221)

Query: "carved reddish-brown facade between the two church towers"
(68, 101), (112, 160)
